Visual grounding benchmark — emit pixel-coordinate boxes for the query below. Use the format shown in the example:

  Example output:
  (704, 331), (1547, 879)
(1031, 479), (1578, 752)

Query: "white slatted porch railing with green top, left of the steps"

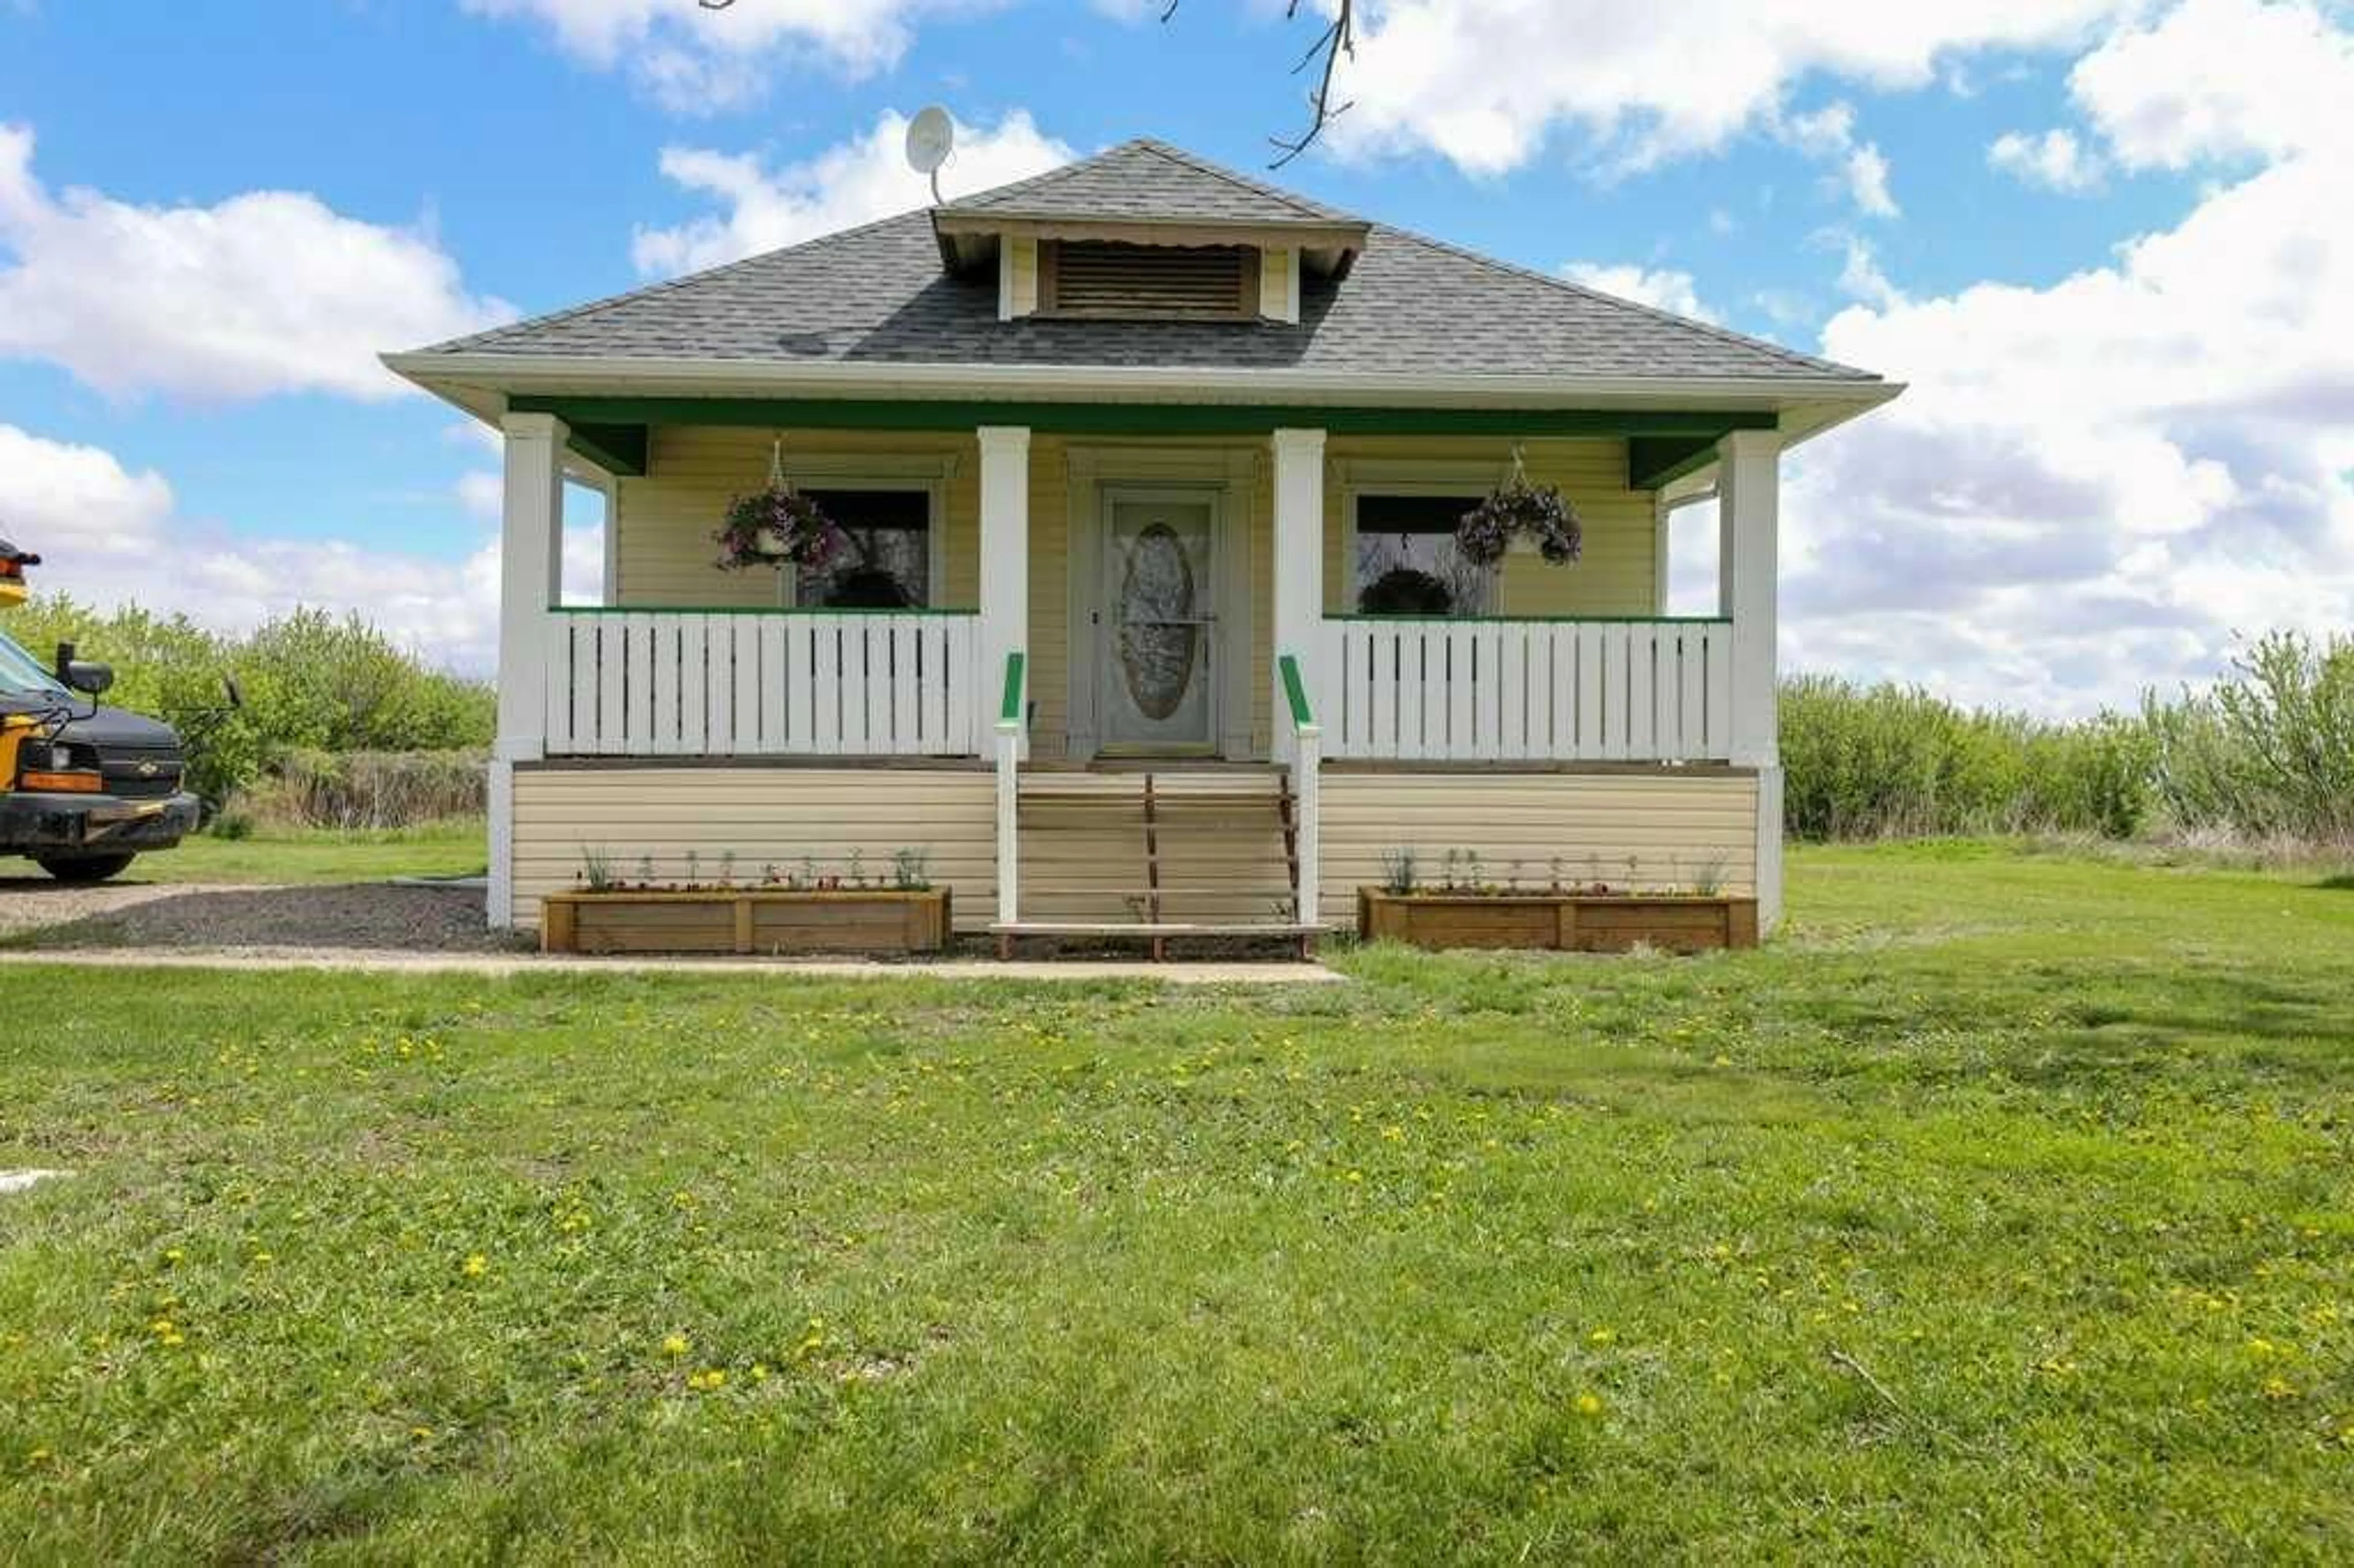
(546, 607), (981, 756)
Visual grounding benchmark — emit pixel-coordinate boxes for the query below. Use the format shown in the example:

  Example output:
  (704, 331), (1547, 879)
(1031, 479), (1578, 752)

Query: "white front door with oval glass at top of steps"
(1095, 490), (1217, 753)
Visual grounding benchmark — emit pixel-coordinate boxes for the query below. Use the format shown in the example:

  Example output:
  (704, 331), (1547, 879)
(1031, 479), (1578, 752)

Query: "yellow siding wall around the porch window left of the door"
(612, 426), (981, 610)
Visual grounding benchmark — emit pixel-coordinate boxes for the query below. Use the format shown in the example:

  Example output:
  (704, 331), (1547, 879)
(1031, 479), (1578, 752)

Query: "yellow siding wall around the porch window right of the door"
(1325, 436), (1659, 614)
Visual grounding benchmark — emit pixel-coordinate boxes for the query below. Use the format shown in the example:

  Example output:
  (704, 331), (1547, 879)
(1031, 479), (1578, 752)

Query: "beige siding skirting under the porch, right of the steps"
(1320, 765), (1758, 927)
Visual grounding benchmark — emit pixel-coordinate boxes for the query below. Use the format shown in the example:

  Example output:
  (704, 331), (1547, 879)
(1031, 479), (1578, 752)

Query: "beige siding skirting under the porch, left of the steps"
(516, 765), (998, 930)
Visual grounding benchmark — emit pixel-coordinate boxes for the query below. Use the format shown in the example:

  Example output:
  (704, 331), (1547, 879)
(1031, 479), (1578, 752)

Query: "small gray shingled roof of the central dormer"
(942, 137), (1363, 224)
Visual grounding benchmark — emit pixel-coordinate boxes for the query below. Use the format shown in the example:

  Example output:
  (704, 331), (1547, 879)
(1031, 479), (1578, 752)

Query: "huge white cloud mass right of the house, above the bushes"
(1785, 0), (2354, 711)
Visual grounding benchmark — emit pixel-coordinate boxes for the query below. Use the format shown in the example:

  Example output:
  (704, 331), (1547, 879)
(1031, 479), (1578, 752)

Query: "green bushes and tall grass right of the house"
(1782, 633), (2354, 848)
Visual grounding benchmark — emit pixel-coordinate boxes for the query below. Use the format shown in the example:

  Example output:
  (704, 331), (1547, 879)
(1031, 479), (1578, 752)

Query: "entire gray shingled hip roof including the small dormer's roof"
(431, 143), (1876, 381)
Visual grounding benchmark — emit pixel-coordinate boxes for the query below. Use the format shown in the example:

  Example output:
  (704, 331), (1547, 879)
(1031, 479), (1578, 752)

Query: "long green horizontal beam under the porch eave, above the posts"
(508, 395), (1775, 445)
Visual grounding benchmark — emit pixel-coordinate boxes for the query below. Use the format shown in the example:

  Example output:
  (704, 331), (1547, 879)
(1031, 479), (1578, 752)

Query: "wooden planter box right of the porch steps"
(1356, 888), (1758, 954)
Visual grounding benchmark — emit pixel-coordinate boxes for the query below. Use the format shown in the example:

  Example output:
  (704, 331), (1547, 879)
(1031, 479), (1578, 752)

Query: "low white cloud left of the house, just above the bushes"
(0, 424), (605, 676)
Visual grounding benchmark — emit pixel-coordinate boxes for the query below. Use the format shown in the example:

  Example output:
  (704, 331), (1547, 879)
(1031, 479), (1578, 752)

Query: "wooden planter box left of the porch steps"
(539, 888), (949, 954)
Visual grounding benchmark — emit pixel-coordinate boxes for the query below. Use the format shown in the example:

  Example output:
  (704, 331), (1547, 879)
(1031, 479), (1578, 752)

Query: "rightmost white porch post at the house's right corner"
(1716, 431), (1782, 930)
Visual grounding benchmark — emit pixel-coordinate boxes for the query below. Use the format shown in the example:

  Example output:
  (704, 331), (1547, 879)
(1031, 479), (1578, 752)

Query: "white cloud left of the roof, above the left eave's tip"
(0, 125), (511, 400)
